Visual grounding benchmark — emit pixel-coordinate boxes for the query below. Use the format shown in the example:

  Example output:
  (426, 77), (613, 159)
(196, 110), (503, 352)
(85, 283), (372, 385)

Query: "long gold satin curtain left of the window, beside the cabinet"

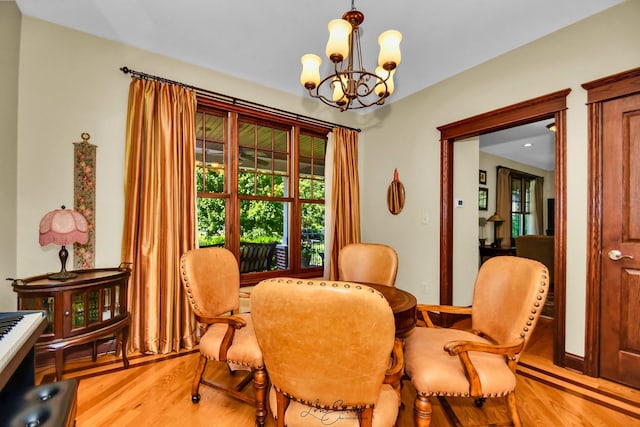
(122, 78), (196, 353)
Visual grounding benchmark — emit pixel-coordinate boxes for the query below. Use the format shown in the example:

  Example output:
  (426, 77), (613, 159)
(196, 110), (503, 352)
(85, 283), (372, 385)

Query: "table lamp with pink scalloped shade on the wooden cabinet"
(40, 205), (89, 280)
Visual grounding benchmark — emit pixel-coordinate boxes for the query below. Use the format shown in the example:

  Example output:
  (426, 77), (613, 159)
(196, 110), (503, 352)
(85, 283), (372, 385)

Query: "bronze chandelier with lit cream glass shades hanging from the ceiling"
(300, 0), (402, 111)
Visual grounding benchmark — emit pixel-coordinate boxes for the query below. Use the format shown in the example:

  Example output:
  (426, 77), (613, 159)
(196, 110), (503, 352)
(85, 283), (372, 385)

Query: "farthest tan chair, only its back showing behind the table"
(338, 243), (398, 286)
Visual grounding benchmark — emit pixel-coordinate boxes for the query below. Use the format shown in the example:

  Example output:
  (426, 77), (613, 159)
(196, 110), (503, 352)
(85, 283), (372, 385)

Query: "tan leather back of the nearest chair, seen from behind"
(251, 278), (395, 408)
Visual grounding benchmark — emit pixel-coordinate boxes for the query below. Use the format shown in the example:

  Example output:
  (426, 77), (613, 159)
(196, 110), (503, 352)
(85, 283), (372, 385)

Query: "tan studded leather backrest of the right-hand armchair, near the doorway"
(471, 256), (549, 360)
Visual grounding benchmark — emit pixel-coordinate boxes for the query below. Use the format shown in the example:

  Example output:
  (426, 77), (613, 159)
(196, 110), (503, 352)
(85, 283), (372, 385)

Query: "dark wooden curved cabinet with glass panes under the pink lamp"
(12, 266), (131, 380)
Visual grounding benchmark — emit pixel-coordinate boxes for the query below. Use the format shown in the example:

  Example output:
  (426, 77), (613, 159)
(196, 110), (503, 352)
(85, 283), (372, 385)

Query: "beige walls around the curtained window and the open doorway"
(7, 0), (640, 355)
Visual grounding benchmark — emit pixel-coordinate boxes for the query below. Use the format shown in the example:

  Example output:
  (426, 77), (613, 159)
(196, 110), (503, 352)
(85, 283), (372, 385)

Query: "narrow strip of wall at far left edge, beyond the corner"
(0, 2), (20, 312)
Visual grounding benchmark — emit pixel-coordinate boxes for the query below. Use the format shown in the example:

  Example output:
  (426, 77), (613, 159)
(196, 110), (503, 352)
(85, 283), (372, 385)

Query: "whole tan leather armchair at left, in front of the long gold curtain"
(180, 247), (268, 426)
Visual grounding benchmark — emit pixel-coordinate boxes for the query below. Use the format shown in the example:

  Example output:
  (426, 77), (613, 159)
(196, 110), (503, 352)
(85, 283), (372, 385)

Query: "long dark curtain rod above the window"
(120, 66), (361, 132)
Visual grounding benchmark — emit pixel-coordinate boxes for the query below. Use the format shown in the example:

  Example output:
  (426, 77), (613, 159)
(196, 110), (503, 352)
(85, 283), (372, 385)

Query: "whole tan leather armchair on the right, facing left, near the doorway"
(404, 256), (549, 427)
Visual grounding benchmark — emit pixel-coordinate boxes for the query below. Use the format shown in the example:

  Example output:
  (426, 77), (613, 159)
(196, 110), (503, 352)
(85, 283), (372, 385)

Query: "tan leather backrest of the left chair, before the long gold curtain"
(180, 247), (240, 317)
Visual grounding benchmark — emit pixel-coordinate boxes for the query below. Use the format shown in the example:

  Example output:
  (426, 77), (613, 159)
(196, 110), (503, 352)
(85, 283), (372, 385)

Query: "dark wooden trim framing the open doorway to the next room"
(438, 89), (571, 366)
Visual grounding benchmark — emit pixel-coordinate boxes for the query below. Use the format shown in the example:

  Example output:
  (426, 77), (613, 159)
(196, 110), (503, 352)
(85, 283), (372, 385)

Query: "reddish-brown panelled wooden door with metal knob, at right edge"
(599, 93), (640, 388)
